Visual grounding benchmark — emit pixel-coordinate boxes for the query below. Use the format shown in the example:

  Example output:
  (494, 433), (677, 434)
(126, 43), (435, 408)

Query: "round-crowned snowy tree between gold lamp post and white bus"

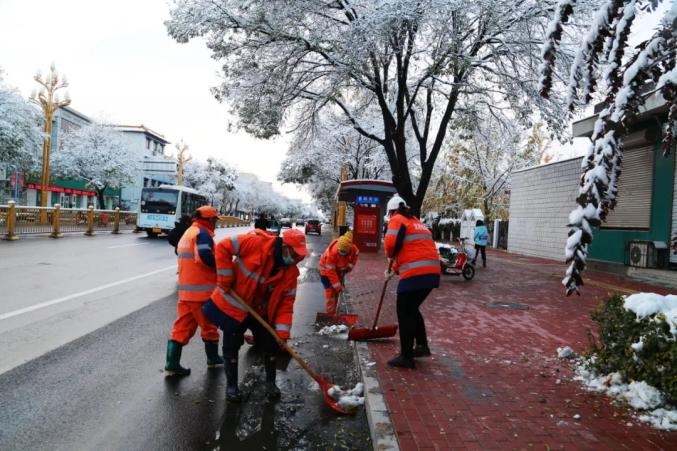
(51, 124), (141, 208)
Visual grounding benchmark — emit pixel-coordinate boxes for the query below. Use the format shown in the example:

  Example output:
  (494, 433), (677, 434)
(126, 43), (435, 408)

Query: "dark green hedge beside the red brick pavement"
(591, 295), (677, 403)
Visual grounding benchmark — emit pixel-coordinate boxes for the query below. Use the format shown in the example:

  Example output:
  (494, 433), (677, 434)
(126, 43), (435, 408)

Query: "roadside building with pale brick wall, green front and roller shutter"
(508, 92), (677, 268)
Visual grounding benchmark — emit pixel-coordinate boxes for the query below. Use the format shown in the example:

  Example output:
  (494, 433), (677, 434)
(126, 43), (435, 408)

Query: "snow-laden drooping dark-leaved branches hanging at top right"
(540, 0), (677, 294)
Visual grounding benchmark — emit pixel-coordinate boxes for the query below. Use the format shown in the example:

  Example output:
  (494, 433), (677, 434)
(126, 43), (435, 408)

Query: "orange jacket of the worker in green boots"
(176, 223), (216, 302)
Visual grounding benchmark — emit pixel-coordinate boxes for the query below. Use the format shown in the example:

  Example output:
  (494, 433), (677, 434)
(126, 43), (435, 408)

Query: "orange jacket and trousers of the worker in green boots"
(171, 219), (219, 346)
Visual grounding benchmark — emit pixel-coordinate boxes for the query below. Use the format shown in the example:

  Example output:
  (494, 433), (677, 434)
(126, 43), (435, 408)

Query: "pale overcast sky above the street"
(0, 0), (310, 200)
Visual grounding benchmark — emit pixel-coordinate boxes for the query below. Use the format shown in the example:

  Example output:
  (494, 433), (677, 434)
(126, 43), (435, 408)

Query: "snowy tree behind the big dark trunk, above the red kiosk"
(278, 112), (391, 212)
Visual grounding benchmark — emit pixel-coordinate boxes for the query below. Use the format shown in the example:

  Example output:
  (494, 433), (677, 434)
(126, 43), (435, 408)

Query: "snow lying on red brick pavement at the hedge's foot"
(574, 357), (677, 431)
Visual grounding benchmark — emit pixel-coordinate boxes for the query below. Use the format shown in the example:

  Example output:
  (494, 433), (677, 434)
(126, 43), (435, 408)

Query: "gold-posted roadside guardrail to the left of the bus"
(0, 201), (137, 241)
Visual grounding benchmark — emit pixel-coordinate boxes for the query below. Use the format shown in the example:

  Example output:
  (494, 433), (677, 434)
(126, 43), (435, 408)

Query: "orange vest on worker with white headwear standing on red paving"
(383, 214), (440, 279)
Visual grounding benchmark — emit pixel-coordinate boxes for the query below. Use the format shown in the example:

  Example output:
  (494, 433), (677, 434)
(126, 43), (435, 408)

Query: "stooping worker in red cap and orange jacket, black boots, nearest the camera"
(203, 229), (308, 402)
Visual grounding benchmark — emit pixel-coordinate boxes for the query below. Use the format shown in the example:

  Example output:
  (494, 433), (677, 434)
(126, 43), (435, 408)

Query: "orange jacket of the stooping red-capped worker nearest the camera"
(211, 229), (300, 340)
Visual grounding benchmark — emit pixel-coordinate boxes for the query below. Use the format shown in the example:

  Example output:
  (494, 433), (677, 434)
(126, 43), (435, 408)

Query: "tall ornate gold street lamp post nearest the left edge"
(30, 63), (71, 223)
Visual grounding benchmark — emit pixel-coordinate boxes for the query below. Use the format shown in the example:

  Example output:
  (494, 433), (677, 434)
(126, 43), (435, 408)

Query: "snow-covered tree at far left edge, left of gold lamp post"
(0, 82), (44, 171)
